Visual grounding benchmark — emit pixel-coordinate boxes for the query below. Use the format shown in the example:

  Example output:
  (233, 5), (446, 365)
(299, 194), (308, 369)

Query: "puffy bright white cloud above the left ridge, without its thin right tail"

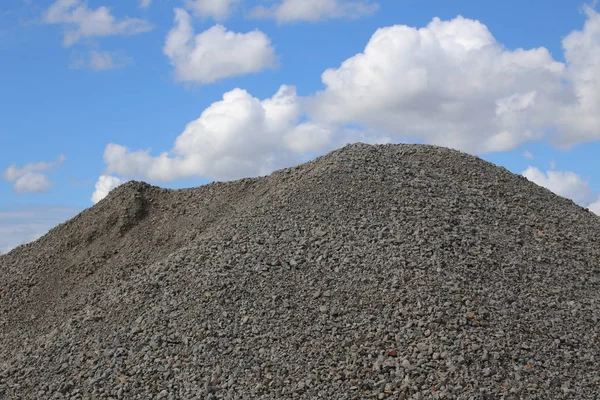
(104, 86), (301, 182)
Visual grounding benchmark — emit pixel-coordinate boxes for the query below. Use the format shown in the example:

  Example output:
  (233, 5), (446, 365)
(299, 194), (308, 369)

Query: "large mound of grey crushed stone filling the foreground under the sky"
(0, 144), (600, 400)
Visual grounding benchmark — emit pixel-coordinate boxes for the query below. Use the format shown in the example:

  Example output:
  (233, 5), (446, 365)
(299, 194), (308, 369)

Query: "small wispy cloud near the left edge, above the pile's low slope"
(4, 154), (65, 194)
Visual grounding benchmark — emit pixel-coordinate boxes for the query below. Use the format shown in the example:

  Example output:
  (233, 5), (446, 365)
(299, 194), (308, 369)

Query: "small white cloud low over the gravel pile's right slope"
(523, 167), (598, 207)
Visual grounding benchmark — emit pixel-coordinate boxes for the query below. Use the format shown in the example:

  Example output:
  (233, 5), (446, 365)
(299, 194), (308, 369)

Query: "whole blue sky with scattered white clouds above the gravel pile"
(0, 0), (600, 252)
